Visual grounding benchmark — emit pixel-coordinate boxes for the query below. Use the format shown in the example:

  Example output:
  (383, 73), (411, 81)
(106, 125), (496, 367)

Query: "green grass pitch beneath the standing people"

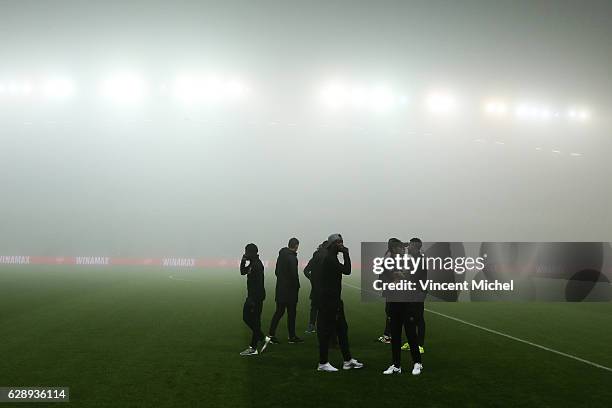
(0, 266), (612, 408)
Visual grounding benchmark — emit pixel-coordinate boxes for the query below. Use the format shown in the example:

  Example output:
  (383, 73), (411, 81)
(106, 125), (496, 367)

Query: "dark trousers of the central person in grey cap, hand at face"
(317, 301), (352, 364)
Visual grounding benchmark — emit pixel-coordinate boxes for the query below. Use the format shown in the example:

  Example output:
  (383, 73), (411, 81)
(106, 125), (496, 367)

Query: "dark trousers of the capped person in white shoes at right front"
(389, 302), (421, 367)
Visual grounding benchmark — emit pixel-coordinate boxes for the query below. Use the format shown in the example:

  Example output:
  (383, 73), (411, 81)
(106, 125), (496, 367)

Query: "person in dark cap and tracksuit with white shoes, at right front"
(381, 238), (423, 375)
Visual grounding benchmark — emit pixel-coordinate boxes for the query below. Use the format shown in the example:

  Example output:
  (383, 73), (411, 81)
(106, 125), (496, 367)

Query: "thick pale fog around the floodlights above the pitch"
(0, 0), (612, 258)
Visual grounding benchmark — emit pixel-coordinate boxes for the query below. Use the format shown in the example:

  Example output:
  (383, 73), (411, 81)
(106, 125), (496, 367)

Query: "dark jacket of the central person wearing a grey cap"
(315, 250), (351, 306)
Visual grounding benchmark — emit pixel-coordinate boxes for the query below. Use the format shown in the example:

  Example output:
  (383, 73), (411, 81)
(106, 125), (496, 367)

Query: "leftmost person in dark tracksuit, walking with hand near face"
(240, 244), (266, 356)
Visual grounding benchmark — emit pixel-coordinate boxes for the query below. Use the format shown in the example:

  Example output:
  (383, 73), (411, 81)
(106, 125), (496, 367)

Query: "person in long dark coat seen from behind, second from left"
(266, 238), (304, 344)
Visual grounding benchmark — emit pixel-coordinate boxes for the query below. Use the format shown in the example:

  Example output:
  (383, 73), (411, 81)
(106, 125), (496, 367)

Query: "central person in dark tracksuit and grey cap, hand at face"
(313, 234), (363, 371)
